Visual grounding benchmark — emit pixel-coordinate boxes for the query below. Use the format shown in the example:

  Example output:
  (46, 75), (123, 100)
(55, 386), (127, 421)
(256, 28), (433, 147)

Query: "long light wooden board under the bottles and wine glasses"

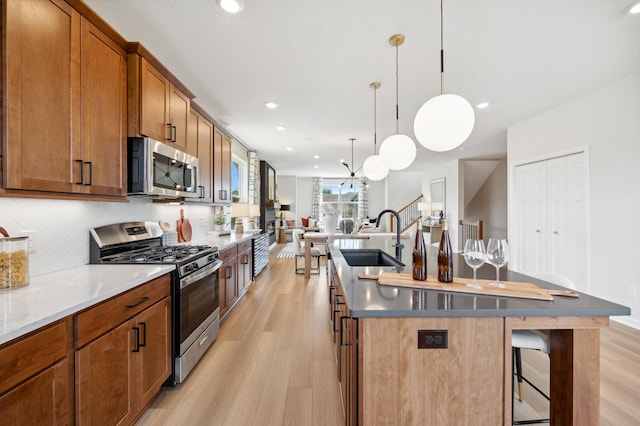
(358, 272), (578, 300)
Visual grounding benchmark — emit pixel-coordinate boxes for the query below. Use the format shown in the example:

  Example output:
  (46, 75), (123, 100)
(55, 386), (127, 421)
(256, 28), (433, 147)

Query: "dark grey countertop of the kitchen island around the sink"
(329, 237), (631, 318)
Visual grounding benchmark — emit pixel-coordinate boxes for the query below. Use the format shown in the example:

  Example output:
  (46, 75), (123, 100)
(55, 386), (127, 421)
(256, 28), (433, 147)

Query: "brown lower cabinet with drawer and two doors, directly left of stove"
(75, 275), (172, 425)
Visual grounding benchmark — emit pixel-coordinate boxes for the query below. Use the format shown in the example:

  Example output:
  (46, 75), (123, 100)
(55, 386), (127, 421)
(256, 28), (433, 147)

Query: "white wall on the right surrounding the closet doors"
(507, 73), (640, 328)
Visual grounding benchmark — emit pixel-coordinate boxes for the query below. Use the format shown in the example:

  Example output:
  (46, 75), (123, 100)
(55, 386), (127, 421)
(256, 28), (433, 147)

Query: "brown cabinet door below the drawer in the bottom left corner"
(0, 359), (73, 426)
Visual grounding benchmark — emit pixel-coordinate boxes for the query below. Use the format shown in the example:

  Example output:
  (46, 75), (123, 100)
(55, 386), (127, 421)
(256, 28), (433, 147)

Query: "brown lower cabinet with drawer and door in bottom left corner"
(0, 319), (73, 426)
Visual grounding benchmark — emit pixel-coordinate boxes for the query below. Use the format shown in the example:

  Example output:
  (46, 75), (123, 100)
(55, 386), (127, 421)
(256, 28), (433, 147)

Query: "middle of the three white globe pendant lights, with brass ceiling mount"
(380, 34), (416, 170)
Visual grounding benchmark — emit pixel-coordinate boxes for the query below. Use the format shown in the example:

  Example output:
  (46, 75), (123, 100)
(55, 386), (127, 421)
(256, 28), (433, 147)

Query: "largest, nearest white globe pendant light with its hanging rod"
(413, 0), (475, 152)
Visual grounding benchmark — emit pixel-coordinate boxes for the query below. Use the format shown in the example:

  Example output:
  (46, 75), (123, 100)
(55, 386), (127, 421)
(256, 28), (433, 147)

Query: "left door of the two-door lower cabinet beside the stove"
(76, 320), (137, 425)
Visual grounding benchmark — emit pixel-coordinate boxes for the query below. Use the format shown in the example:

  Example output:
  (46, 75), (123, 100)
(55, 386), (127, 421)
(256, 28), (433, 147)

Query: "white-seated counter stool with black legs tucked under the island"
(511, 272), (575, 425)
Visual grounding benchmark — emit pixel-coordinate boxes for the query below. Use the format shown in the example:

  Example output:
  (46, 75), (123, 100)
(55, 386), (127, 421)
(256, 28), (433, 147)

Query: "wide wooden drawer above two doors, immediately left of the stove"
(74, 274), (171, 348)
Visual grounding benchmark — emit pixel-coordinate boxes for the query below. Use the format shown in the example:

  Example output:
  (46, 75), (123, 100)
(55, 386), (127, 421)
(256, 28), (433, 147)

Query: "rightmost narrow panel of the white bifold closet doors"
(562, 152), (589, 291)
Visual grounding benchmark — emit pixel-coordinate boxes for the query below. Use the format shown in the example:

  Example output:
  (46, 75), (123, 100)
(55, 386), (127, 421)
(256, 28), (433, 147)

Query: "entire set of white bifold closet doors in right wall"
(512, 153), (589, 291)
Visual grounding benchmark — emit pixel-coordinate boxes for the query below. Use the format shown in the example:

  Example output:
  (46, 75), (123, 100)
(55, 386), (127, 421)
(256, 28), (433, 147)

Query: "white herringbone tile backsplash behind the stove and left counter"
(0, 198), (214, 276)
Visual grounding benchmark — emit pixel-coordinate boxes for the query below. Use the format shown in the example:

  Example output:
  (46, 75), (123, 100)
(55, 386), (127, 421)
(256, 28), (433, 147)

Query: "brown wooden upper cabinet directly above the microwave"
(128, 43), (198, 156)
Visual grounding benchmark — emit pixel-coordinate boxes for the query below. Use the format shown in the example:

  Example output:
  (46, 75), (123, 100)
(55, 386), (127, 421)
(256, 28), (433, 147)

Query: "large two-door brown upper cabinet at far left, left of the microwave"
(2, 0), (127, 196)
